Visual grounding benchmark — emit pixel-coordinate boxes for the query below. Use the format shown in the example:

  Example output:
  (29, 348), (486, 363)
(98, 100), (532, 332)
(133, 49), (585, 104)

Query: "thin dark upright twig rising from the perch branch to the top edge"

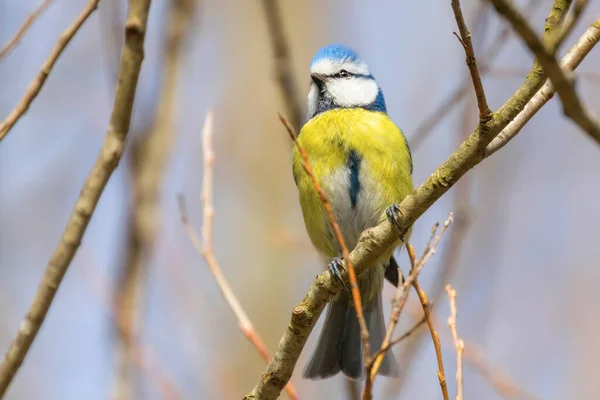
(452, 0), (492, 123)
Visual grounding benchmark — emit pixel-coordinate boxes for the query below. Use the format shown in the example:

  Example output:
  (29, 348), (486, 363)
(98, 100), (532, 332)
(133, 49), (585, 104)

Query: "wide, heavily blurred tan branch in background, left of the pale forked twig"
(115, 0), (197, 399)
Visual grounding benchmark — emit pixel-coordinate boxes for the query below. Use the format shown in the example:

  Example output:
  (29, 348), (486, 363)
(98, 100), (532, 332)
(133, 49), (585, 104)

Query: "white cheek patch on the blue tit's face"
(327, 78), (379, 107)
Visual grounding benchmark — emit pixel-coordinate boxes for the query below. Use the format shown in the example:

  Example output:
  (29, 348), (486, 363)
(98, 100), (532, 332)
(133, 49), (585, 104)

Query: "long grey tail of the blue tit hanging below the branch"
(304, 291), (398, 379)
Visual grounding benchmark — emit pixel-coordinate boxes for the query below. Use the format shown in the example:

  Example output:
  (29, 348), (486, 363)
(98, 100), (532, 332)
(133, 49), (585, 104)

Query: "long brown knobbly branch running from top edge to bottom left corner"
(0, 0), (150, 398)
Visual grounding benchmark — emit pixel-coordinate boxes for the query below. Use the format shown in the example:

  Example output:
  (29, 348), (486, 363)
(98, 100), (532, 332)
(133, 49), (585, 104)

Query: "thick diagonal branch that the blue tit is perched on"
(245, 0), (595, 399)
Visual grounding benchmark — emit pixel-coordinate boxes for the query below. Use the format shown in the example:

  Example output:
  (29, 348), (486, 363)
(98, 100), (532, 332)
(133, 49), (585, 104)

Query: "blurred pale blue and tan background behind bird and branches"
(0, 0), (600, 400)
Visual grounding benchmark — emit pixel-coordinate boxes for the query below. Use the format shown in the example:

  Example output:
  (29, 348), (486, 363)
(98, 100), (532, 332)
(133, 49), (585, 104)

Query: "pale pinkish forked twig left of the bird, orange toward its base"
(178, 112), (297, 399)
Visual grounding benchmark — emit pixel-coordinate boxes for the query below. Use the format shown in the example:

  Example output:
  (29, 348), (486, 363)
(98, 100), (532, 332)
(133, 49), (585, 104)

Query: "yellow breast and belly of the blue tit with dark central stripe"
(293, 109), (413, 257)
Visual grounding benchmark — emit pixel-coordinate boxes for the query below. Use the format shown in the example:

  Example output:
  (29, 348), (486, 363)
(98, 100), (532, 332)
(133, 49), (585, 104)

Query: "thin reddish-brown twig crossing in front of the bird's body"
(279, 114), (371, 382)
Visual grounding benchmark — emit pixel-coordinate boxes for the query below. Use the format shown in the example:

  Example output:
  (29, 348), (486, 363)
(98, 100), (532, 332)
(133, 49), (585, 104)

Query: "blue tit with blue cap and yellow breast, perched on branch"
(293, 45), (413, 379)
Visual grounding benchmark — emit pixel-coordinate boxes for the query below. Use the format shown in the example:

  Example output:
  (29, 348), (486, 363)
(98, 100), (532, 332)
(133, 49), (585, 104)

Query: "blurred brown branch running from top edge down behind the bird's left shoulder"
(262, 0), (303, 129)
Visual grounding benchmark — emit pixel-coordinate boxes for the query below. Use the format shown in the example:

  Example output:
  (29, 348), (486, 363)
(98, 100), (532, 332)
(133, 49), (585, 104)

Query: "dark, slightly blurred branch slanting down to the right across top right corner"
(490, 0), (600, 144)
